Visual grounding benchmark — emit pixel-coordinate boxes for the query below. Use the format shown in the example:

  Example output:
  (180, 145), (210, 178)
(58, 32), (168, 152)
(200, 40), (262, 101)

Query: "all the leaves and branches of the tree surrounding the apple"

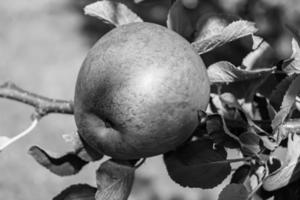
(0, 0), (300, 200)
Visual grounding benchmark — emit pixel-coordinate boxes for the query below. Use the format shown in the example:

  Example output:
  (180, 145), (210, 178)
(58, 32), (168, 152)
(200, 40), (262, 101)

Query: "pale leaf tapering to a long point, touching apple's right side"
(207, 61), (275, 84)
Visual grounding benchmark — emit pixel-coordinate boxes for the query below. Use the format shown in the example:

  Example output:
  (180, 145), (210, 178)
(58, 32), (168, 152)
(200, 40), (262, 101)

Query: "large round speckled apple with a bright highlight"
(74, 22), (210, 160)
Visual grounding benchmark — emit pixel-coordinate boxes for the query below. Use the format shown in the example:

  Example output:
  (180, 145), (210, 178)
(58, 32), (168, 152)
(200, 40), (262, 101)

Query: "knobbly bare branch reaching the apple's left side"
(0, 82), (74, 117)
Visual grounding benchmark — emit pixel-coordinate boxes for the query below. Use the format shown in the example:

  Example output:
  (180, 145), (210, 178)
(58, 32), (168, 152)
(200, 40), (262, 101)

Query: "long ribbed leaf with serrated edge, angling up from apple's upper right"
(192, 20), (257, 54)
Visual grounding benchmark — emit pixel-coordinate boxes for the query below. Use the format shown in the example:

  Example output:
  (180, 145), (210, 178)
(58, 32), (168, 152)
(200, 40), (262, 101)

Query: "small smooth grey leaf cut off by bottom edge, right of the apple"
(218, 183), (249, 200)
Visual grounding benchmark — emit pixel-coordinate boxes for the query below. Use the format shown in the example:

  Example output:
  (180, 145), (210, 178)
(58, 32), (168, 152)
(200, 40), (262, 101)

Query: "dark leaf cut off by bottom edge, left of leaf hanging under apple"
(53, 184), (97, 200)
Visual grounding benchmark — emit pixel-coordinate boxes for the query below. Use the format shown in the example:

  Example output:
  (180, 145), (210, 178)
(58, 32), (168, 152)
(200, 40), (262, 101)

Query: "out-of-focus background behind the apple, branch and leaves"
(0, 0), (300, 200)
